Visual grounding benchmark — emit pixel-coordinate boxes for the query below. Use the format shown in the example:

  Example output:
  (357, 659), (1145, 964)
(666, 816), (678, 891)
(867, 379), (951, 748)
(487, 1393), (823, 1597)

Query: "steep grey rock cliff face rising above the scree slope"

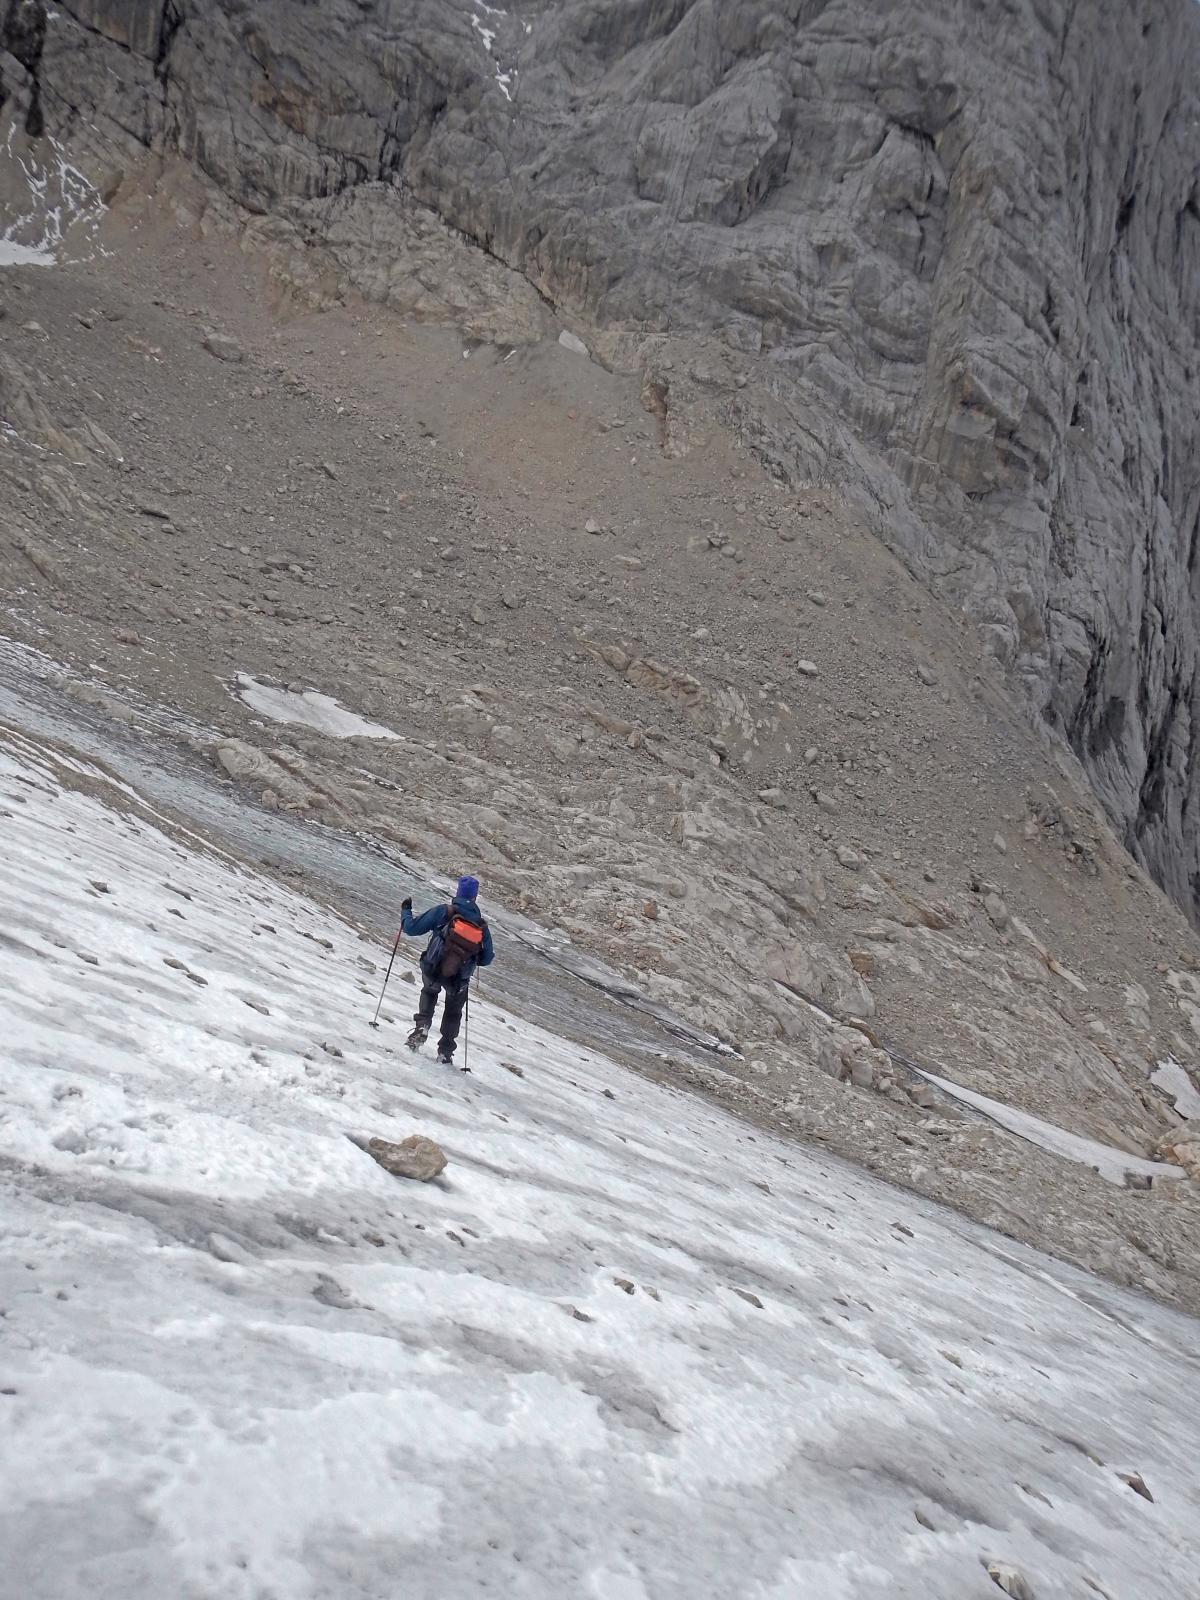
(0, 0), (1200, 914)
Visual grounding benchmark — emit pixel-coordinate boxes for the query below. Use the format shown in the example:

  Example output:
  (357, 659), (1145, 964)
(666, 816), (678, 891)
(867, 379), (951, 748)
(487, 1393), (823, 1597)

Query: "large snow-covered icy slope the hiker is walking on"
(0, 734), (1200, 1600)
